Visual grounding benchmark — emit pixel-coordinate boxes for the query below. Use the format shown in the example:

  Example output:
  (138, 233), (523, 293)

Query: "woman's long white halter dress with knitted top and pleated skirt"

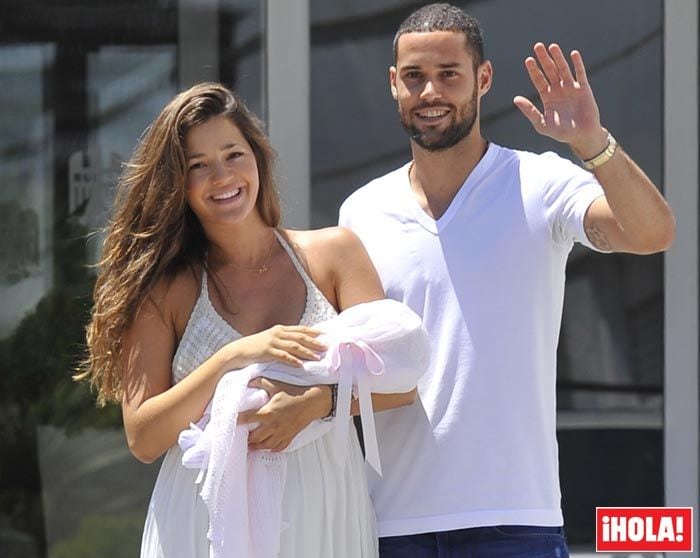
(141, 234), (378, 558)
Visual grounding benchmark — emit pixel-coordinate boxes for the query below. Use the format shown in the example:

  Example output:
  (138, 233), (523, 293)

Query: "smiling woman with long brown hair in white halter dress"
(79, 83), (415, 558)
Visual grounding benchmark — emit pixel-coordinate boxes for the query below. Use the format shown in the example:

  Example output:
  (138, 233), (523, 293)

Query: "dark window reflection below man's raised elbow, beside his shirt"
(558, 250), (663, 416)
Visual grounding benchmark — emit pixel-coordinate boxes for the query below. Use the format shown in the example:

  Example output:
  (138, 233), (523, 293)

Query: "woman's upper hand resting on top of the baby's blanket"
(224, 325), (327, 369)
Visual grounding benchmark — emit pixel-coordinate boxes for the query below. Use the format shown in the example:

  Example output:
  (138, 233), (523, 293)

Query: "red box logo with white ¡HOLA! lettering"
(595, 508), (693, 552)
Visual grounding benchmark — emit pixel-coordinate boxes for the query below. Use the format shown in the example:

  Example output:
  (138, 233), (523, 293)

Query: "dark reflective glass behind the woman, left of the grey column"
(0, 0), (264, 558)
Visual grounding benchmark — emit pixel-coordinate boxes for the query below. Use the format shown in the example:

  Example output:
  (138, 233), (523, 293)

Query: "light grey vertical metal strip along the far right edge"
(664, 0), (700, 557)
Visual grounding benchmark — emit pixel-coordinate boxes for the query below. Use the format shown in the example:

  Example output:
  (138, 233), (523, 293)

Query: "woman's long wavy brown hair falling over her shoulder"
(74, 83), (280, 406)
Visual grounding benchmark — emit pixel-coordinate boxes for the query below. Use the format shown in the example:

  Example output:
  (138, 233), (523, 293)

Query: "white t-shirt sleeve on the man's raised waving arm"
(539, 153), (605, 252)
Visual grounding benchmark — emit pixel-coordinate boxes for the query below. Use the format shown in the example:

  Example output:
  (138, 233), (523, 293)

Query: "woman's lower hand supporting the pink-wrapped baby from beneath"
(238, 378), (332, 451)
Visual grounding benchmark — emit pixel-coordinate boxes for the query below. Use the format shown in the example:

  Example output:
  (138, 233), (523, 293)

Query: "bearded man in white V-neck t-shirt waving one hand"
(340, 4), (675, 558)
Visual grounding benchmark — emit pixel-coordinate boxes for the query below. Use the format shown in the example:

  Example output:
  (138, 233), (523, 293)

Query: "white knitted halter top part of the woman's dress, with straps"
(172, 230), (338, 384)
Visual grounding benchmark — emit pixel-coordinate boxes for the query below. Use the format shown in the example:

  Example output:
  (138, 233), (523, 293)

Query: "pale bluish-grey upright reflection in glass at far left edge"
(0, 45), (55, 337)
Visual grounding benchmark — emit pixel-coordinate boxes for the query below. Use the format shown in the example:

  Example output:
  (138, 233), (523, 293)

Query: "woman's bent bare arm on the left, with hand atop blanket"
(122, 276), (324, 463)
